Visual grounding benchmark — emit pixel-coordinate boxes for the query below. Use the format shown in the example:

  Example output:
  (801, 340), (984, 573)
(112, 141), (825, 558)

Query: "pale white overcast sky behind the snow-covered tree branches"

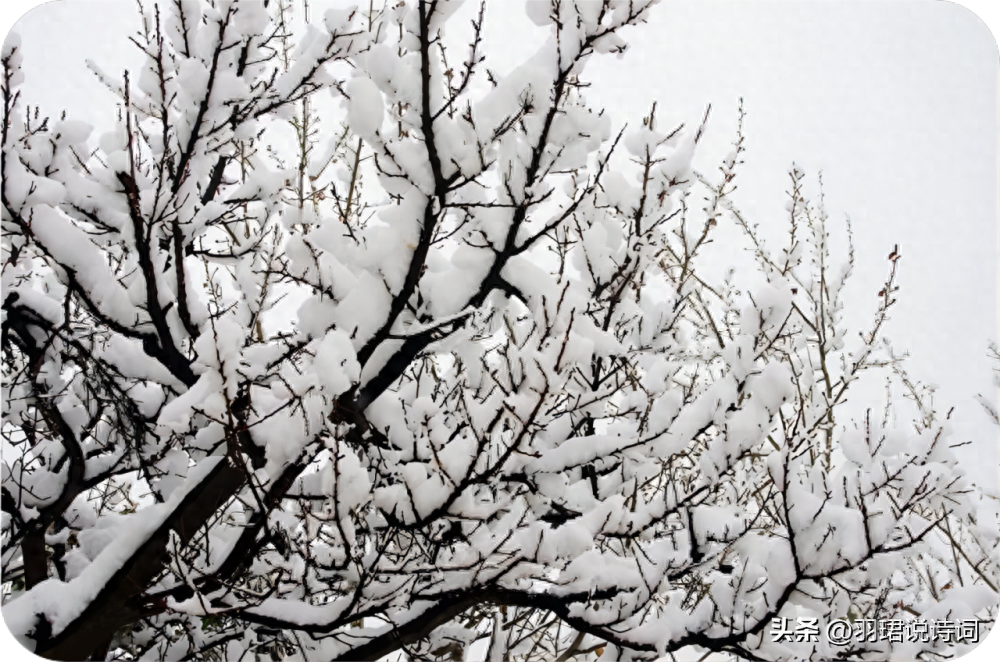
(3, 0), (1000, 494)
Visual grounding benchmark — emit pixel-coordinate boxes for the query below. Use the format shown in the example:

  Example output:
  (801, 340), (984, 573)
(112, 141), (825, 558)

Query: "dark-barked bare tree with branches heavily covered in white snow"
(0, 0), (1000, 660)
